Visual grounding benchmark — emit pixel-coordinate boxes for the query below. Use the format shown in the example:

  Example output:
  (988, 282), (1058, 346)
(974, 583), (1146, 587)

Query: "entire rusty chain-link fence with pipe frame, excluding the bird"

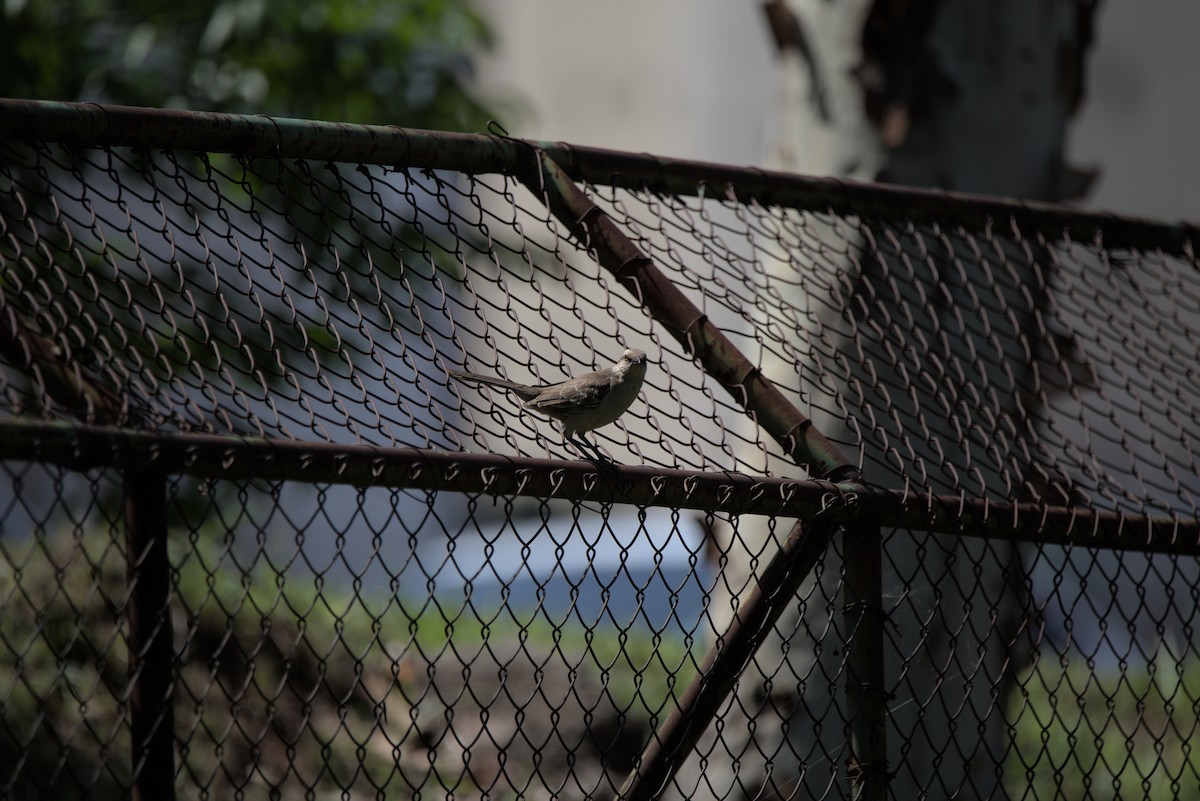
(0, 101), (1200, 801)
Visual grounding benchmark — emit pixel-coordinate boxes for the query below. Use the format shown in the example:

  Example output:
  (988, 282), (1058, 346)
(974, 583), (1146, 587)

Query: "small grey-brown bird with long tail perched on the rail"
(448, 348), (646, 458)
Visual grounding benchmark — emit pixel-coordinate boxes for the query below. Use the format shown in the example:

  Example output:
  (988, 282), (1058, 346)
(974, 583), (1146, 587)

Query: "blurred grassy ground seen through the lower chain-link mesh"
(0, 526), (1200, 800)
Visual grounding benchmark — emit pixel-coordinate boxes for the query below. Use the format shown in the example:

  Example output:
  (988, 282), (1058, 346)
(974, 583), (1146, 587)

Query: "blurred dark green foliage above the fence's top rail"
(0, 0), (491, 130)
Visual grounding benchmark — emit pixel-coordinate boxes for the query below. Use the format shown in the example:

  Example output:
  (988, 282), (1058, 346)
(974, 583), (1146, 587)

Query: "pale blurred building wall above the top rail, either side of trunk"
(479, 0), (1200, 219)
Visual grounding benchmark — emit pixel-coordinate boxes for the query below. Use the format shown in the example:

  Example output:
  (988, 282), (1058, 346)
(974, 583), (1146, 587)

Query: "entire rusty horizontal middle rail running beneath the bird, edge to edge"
(0, 418), (1200, 556)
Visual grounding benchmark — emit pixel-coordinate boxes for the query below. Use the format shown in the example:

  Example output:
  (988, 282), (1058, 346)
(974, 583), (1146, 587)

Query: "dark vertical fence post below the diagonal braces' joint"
(842, 518), (888, 801)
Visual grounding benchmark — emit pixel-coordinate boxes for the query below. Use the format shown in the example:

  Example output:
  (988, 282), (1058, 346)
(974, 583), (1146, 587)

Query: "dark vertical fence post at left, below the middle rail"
(125, 468), (175, 801)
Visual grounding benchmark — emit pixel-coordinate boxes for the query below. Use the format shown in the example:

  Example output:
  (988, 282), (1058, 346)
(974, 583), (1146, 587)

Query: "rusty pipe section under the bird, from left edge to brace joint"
(0, 420), (864, 518)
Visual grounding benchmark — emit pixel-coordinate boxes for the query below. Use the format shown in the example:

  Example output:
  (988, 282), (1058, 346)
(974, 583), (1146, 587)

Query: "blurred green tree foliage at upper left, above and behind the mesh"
(0, 0), (506, 424)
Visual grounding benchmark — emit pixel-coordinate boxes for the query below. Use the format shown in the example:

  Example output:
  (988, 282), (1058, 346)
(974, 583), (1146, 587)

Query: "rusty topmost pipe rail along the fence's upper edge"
(0, 98), (1200, 258)
